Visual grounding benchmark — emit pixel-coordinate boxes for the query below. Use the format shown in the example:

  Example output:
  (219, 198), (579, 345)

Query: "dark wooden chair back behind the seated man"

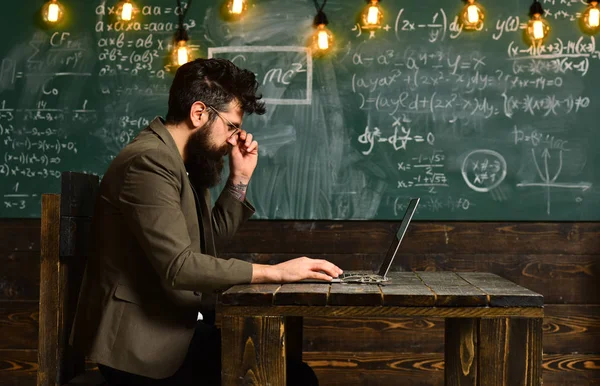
(37, 172), (102, 386)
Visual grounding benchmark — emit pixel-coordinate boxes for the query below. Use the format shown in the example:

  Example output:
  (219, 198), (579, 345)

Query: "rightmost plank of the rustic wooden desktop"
(458, 272), (544, 307)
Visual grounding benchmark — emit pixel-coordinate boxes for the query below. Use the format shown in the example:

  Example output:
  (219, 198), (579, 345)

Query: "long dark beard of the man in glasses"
(185, 127), (229, 188)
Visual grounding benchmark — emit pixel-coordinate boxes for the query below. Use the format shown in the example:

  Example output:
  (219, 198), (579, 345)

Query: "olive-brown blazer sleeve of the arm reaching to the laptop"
(119, 148), (252, 292)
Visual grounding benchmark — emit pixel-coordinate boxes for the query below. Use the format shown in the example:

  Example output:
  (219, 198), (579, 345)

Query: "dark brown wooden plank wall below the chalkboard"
(0, 219), (600, 386)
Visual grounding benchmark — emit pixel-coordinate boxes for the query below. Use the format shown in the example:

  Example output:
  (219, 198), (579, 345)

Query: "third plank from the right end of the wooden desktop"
(380, 272), (435, 307)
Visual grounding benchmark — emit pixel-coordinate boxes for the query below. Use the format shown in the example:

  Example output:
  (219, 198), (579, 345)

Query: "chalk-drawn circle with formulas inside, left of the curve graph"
(461, 149), (506, 192)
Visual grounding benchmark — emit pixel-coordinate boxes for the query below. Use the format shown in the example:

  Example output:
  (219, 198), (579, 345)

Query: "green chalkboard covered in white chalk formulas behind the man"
(0, 0), (600, 221)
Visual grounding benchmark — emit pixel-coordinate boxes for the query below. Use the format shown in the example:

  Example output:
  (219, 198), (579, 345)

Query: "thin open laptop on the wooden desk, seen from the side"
(302, 198), (419, 284)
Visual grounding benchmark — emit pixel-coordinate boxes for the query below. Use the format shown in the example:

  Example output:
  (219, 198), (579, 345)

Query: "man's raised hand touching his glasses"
(227, 130), (258, 184)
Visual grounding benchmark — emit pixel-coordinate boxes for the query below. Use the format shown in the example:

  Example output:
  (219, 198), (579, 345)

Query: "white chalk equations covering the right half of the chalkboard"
(345, 2), (600, 215)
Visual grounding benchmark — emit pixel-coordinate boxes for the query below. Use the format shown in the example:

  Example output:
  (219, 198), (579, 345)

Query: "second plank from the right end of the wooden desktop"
(416, 272), (488, 307)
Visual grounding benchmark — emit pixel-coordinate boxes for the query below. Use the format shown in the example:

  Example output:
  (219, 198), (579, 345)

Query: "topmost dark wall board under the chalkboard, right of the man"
(227, 221), (600, 255)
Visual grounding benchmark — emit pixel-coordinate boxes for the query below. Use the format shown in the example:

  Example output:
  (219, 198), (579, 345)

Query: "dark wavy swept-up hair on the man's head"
(166, 58), (265, 123)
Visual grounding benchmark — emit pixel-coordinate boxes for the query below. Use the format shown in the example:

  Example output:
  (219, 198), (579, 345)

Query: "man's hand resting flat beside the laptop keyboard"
(252, 257), (343, 283)
